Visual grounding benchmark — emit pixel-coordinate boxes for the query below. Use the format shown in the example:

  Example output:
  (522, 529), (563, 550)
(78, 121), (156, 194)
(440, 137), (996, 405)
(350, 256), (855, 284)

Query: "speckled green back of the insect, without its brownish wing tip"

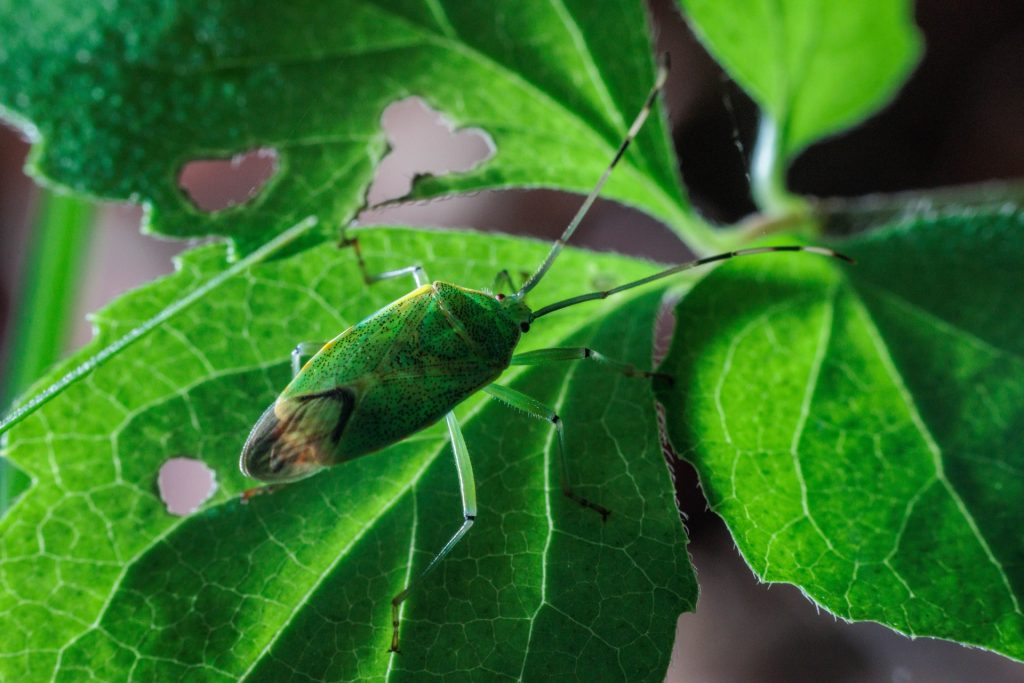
(278, 283), (520, 464)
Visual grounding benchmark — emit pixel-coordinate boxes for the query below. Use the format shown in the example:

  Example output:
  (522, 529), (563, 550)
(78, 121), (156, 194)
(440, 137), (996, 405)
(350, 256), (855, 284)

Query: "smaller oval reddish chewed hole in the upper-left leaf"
(178, 147), (278, 212)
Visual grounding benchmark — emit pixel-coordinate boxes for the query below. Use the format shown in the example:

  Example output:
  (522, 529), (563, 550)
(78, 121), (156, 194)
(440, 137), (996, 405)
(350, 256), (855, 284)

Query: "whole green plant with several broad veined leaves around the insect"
(0, 0), (1024, 681)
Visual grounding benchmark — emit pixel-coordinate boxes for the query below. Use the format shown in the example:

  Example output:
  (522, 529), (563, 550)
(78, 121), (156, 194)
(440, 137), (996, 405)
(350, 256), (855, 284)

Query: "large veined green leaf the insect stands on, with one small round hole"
(0, 228), (696, 681)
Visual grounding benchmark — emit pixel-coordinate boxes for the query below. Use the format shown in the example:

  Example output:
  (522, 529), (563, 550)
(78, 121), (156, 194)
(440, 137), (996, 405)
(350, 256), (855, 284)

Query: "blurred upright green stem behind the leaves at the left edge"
(0, 190), (93, 513)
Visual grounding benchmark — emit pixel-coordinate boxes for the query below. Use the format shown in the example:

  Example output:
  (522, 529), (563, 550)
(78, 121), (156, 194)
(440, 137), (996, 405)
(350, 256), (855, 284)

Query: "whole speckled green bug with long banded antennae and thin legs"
(240, 53), (850, 651)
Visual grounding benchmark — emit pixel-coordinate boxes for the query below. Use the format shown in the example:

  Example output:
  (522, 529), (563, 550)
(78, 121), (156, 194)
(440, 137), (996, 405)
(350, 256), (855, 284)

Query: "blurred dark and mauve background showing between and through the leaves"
(0, 0), (1024, 683)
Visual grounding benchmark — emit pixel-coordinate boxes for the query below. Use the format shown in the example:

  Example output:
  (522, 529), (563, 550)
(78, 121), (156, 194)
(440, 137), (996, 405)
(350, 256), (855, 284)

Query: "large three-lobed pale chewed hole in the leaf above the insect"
(367, 97), (496, 206)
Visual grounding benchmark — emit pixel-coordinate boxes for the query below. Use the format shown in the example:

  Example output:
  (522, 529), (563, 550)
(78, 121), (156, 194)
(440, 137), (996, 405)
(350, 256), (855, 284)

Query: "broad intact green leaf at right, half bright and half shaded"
(660, 209), (1024, 659)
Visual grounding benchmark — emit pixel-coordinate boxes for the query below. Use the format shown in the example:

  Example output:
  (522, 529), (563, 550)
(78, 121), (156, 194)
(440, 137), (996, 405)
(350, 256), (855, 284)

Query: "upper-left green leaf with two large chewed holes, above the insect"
(0, 0), (713, 250)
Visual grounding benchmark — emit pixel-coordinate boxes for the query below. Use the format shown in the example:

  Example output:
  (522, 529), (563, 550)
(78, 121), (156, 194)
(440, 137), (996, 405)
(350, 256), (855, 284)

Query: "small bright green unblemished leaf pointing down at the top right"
(680, 0), (922, 163)
